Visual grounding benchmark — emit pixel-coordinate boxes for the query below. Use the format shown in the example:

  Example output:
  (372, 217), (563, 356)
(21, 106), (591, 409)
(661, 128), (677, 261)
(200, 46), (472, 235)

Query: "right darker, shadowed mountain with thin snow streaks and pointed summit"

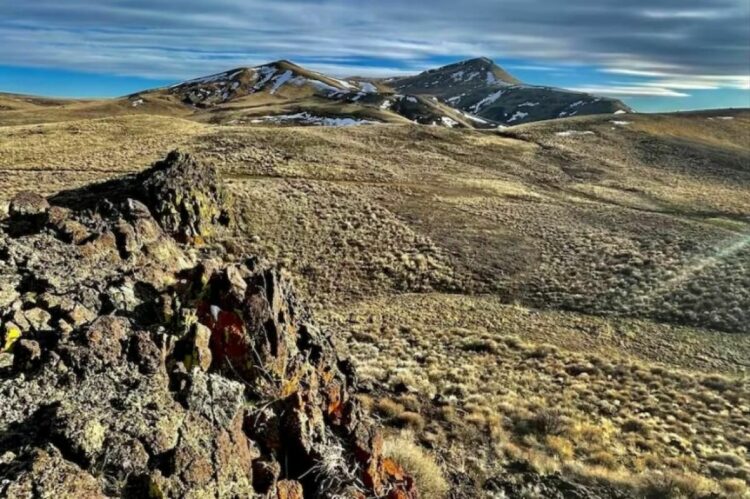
(387, 57), (632, 125)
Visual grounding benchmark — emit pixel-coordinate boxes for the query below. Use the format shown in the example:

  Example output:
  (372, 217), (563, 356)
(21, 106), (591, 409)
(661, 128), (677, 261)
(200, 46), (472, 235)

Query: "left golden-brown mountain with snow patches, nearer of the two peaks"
(128, 60), (472, 128)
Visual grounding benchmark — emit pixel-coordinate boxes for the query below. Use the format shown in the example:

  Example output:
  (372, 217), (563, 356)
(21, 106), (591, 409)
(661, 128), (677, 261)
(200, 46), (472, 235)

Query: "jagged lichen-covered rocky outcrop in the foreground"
(0, 153), (418, 498)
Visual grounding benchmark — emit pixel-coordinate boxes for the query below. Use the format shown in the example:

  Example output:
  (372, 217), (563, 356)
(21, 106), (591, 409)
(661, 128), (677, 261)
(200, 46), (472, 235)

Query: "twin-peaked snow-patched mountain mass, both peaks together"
(137, 58), (631, 128)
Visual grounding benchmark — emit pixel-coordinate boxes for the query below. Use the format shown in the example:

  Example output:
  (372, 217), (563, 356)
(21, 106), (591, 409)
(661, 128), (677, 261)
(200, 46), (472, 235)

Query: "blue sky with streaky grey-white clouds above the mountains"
(0, 0), (750, 112)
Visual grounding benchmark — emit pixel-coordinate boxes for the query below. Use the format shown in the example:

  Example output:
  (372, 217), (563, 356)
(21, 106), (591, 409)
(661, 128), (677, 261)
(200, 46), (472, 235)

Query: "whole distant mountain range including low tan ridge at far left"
(0, 58), (630, 129)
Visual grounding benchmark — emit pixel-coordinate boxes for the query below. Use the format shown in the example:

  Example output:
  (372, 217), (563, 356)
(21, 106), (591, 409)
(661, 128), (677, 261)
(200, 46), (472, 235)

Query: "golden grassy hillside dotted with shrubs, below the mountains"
(0, 108), (750, 497)
